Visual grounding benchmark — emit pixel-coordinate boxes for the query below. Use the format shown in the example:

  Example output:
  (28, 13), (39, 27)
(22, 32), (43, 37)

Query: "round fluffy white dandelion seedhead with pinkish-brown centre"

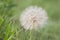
(20, 6), (48, 30)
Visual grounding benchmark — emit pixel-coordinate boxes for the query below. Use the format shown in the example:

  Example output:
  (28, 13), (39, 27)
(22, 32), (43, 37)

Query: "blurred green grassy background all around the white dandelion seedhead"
(0, 0), (60, 40)
